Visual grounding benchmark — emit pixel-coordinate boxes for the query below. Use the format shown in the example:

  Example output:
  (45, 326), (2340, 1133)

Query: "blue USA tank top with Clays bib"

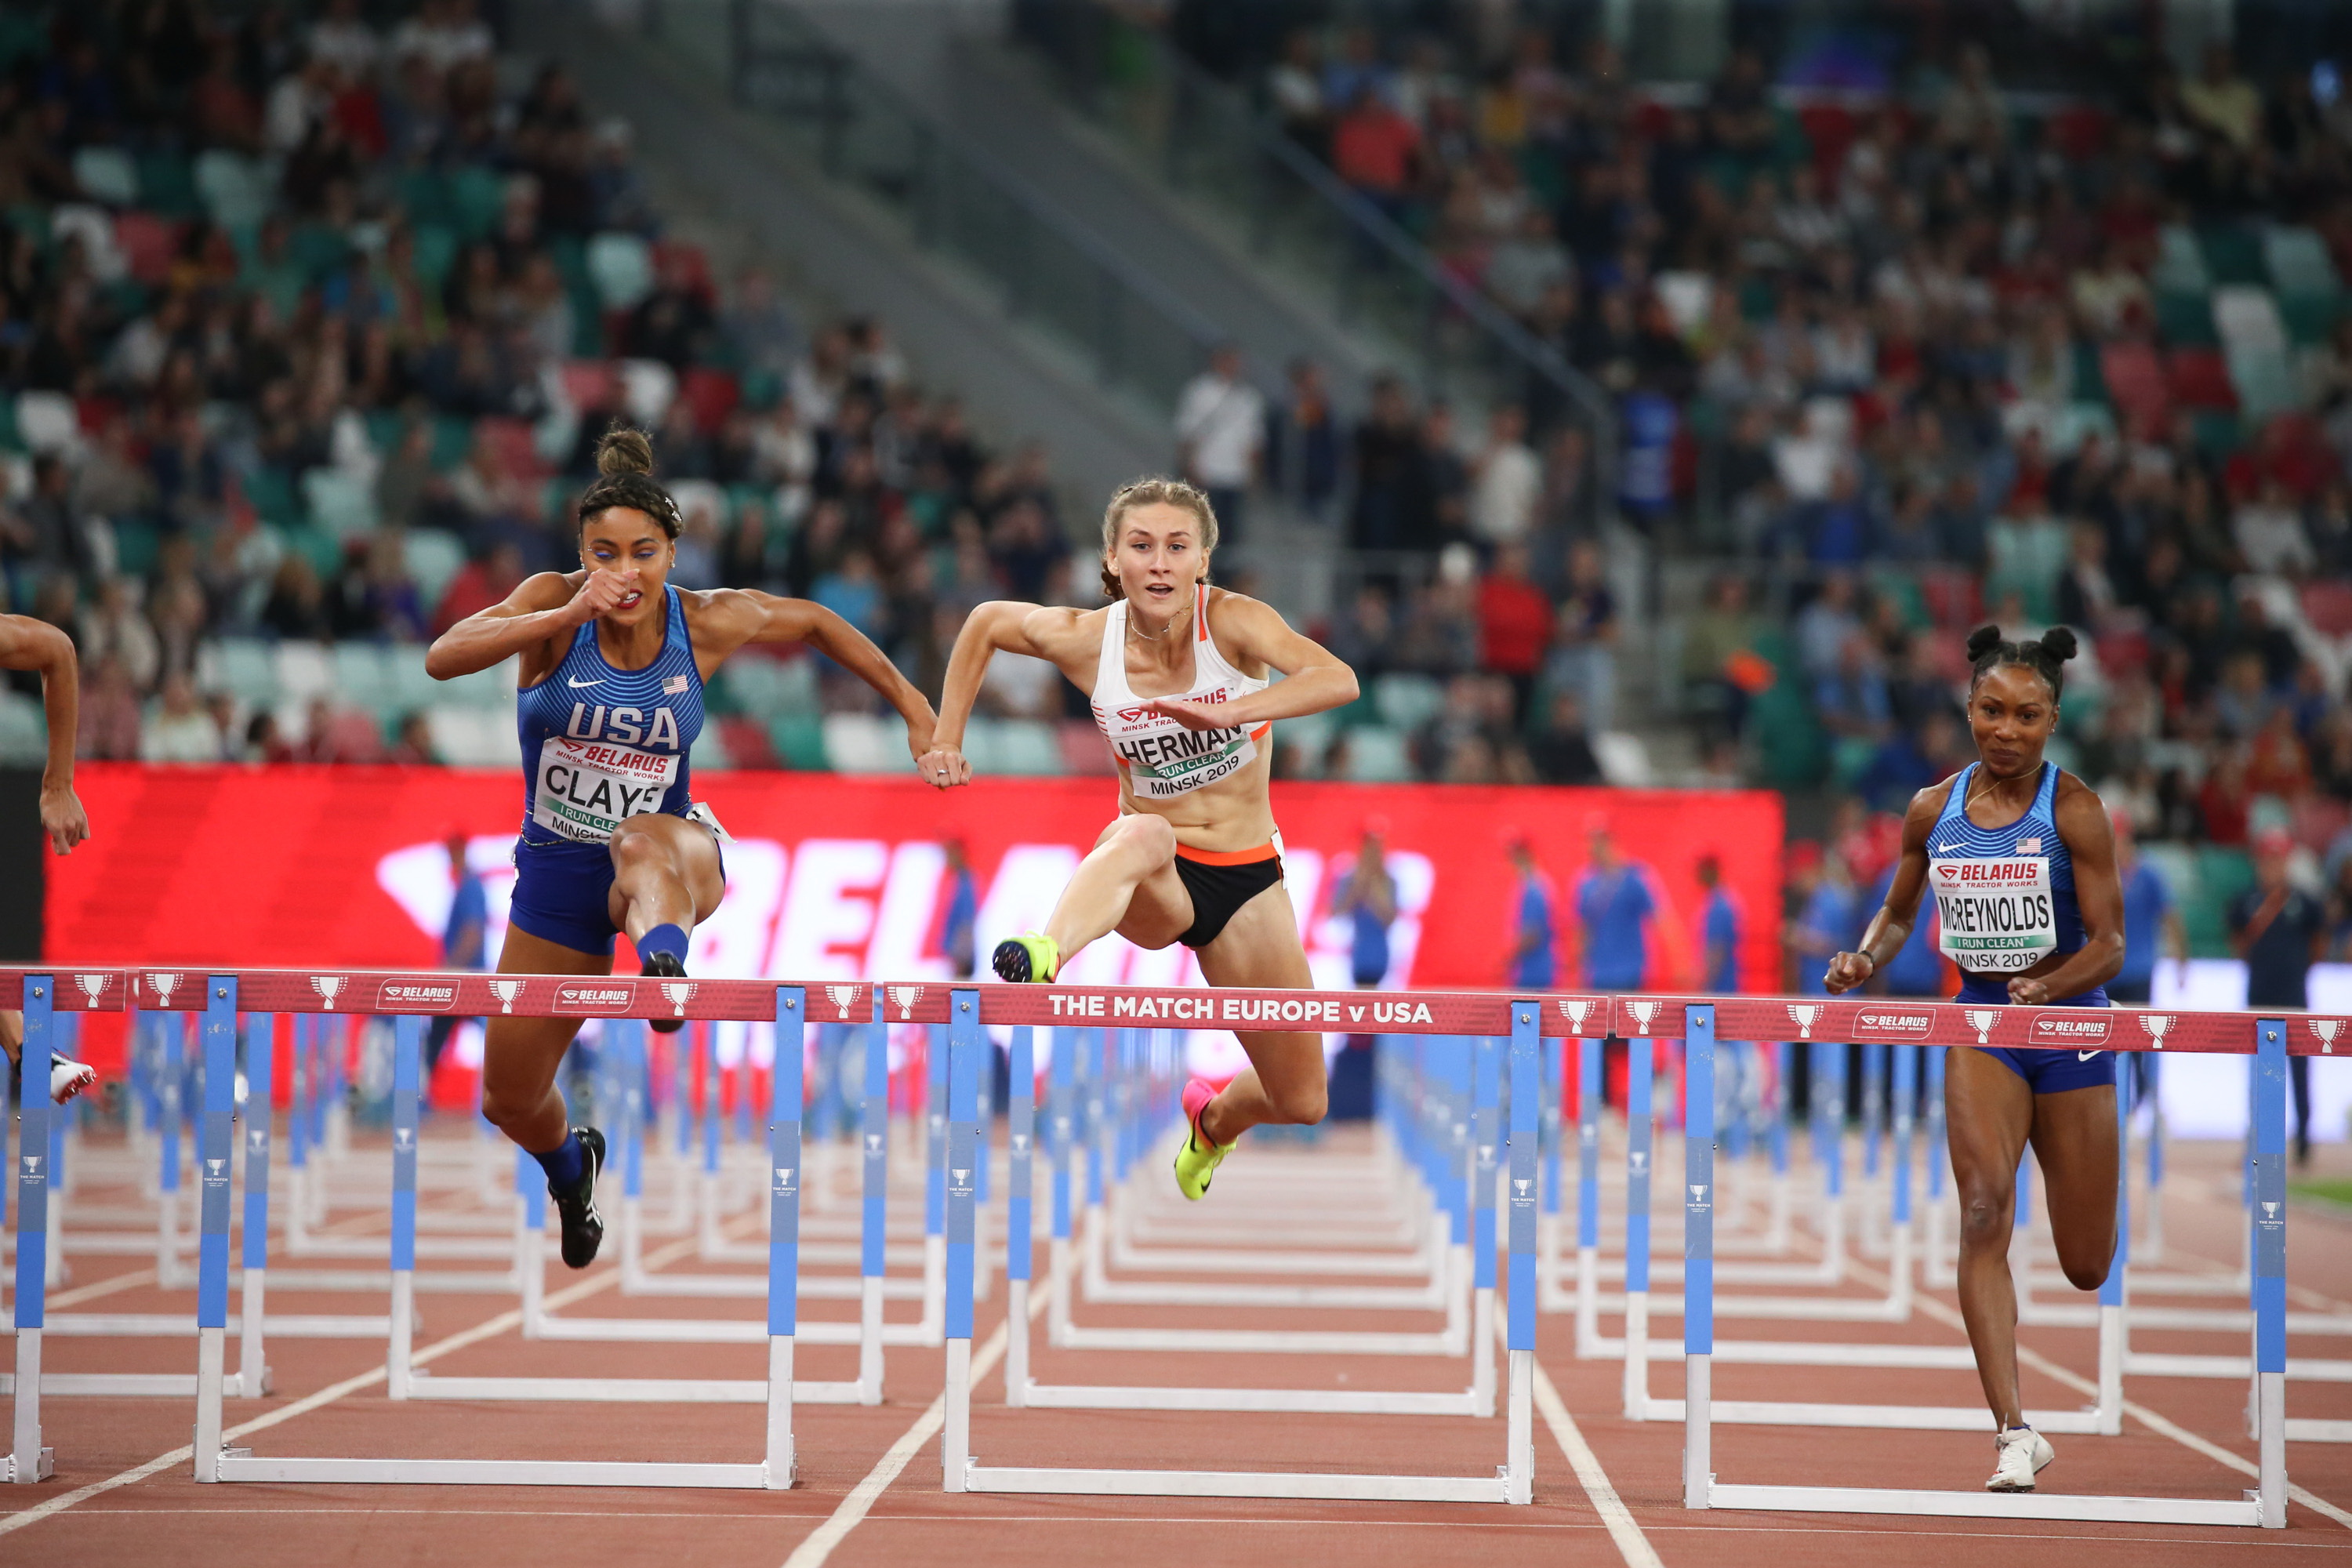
(515, 583), (703, 844)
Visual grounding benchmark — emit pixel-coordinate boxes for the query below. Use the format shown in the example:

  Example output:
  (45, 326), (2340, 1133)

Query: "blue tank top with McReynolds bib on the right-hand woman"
(1926, 762), (2082, 975)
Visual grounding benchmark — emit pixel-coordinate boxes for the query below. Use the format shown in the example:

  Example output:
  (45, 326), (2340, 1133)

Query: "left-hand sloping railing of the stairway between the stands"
(647, 0), (1221, 414)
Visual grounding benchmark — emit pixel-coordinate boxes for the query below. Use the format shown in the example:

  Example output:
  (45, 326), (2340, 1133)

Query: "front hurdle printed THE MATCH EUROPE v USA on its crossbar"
(941, 987), (1545, 1504)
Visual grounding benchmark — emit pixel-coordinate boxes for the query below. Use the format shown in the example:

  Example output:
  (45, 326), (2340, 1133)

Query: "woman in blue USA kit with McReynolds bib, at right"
(1828, 626), (2124, 1493)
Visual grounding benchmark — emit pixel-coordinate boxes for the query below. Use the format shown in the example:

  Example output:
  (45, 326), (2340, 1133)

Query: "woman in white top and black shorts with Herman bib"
(920, 480), (1355, 1199)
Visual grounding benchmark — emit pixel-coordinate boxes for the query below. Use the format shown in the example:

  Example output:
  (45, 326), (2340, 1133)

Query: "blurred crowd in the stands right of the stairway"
(1195, 12), (2352, 881)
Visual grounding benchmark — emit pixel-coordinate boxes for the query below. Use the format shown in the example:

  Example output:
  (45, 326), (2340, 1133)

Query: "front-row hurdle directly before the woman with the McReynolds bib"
(1665, 999), (2286, 1528)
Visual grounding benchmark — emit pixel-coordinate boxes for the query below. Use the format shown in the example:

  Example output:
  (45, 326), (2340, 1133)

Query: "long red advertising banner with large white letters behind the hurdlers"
(45, 764), (1783, 992)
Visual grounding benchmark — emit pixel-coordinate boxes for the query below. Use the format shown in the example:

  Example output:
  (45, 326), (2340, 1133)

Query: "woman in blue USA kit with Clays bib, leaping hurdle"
(426, 430), (931, 1269)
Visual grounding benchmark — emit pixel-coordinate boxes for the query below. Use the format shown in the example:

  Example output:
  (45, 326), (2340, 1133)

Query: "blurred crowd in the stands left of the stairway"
(0, 0), (1068, 762)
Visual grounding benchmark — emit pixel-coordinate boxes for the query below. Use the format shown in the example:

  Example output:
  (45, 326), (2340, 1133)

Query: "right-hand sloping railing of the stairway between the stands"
(1011, 0), (1618, 506)
